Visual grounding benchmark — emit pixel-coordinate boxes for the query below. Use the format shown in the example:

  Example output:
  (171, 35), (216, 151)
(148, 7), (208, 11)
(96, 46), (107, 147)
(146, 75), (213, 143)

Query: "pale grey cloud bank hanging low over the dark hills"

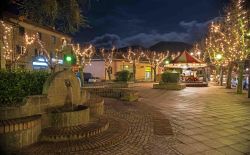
(91, 18), (218, 48)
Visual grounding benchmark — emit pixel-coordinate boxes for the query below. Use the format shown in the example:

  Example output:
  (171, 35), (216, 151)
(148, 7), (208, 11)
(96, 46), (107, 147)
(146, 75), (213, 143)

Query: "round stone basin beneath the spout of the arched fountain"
(49, 105), (90, 127)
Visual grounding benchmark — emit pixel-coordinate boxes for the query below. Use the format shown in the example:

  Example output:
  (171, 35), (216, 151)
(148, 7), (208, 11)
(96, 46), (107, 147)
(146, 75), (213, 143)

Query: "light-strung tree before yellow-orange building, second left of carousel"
(122, 48), (145, 81)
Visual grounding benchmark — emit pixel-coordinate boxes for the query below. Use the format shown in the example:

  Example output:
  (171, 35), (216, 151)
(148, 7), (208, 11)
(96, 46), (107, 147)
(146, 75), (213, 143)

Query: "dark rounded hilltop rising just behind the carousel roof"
(149, 41), (192, 53)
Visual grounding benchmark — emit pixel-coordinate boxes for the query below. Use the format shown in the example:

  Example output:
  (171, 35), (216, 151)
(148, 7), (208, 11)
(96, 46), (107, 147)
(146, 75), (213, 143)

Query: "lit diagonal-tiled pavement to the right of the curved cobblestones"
(138, 84), (250, 155)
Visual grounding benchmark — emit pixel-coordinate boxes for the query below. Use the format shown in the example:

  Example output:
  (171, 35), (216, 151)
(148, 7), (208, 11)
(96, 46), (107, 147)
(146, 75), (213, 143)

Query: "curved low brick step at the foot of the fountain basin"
(41, 117), (109, 142)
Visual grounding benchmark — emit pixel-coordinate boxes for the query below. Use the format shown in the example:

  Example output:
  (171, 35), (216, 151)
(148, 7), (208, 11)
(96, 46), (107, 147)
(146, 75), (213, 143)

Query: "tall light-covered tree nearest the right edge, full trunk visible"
(225, 0), (249, 94)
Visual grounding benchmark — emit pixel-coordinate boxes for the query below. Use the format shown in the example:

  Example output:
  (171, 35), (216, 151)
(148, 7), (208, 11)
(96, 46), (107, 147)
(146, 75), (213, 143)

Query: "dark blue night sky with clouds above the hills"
(74, 0), (229, 47)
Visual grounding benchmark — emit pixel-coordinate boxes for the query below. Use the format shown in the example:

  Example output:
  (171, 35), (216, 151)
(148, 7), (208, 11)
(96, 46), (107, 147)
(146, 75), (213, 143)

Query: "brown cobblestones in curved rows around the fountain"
(21, 99), (178, 155)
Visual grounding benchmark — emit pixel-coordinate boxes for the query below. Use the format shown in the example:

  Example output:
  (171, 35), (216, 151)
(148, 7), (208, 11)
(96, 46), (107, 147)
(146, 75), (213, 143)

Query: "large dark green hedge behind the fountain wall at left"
(0, 70), (49, 106)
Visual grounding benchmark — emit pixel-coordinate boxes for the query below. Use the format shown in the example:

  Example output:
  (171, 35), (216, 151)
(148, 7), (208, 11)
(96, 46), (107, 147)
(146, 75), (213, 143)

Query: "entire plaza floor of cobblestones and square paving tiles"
(23, 84), (250, 155)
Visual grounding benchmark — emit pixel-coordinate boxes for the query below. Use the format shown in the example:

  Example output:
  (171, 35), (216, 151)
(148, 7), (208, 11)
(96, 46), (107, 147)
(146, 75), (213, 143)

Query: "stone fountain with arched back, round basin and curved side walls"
(0, 70), (105, 152)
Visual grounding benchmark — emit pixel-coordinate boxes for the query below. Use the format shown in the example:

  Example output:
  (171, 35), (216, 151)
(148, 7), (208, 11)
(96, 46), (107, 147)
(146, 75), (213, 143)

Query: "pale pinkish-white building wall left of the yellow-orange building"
(84, 60), (105, 80)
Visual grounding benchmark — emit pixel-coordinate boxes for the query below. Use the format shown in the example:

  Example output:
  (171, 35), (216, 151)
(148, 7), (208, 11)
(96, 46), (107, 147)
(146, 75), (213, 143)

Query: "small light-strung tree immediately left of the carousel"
(145, 51), (169, 82)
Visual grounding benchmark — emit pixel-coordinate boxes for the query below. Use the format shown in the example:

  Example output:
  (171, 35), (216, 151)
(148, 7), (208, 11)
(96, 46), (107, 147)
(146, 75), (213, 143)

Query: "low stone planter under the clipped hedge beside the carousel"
(153, 83), (186, 90)
